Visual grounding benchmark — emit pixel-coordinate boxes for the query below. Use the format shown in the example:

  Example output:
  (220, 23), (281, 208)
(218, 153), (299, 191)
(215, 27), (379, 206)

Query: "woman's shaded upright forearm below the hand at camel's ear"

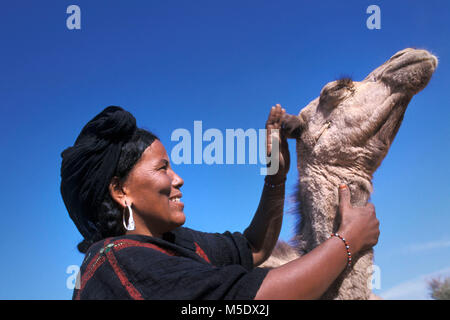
(244, 178), (285, 266)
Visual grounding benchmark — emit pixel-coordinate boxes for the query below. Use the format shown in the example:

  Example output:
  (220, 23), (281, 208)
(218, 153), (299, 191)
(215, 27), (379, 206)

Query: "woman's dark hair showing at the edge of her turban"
(77, 129), (159, 253)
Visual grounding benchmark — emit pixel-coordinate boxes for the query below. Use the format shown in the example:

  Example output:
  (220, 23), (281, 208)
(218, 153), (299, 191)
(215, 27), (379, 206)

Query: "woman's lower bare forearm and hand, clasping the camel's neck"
(255, 187), (380, 300)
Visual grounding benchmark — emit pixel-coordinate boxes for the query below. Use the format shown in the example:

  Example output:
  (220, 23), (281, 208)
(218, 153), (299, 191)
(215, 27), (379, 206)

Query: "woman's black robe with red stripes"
(73, 227), (268, 300)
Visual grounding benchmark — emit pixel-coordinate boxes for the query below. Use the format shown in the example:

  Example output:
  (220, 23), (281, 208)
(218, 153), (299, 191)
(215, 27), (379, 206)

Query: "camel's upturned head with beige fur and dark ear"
(283, 48), (438, 177)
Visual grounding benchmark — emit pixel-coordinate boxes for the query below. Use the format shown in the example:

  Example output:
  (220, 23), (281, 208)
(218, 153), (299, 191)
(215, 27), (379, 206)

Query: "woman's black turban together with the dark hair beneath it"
(61, 106), (159, 253)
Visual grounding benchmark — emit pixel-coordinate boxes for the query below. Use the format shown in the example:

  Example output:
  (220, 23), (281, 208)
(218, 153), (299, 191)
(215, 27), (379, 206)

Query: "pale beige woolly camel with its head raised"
(262, 48), (438, 300)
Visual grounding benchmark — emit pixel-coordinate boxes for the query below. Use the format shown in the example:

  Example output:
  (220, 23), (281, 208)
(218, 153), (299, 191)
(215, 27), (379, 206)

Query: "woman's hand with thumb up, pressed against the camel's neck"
(338, 185), (380, 253)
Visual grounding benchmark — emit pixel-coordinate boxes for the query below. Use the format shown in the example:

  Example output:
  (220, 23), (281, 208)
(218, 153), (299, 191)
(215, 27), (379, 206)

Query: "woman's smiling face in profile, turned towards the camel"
(123, 140), (186, 237)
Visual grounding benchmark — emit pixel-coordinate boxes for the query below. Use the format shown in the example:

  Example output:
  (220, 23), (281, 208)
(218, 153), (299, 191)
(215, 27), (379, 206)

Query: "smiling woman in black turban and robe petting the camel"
(61, 105), (379, 299)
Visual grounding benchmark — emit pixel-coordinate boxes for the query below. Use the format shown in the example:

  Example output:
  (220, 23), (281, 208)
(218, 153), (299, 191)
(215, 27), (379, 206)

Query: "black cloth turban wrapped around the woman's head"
(61, 106), (137, 239)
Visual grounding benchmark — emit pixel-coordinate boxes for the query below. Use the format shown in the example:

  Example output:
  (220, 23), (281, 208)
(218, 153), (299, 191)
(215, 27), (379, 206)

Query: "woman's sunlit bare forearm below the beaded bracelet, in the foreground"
(255, 237), (347, 300)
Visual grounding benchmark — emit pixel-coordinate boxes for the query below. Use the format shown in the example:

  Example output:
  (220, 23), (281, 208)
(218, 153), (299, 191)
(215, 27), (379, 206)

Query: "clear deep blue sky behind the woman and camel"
(0, 0), (450, 299)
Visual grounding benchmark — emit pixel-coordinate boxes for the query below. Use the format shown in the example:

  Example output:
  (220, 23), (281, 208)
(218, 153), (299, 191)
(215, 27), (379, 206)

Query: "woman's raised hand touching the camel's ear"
(266, 104), (291, 184)
